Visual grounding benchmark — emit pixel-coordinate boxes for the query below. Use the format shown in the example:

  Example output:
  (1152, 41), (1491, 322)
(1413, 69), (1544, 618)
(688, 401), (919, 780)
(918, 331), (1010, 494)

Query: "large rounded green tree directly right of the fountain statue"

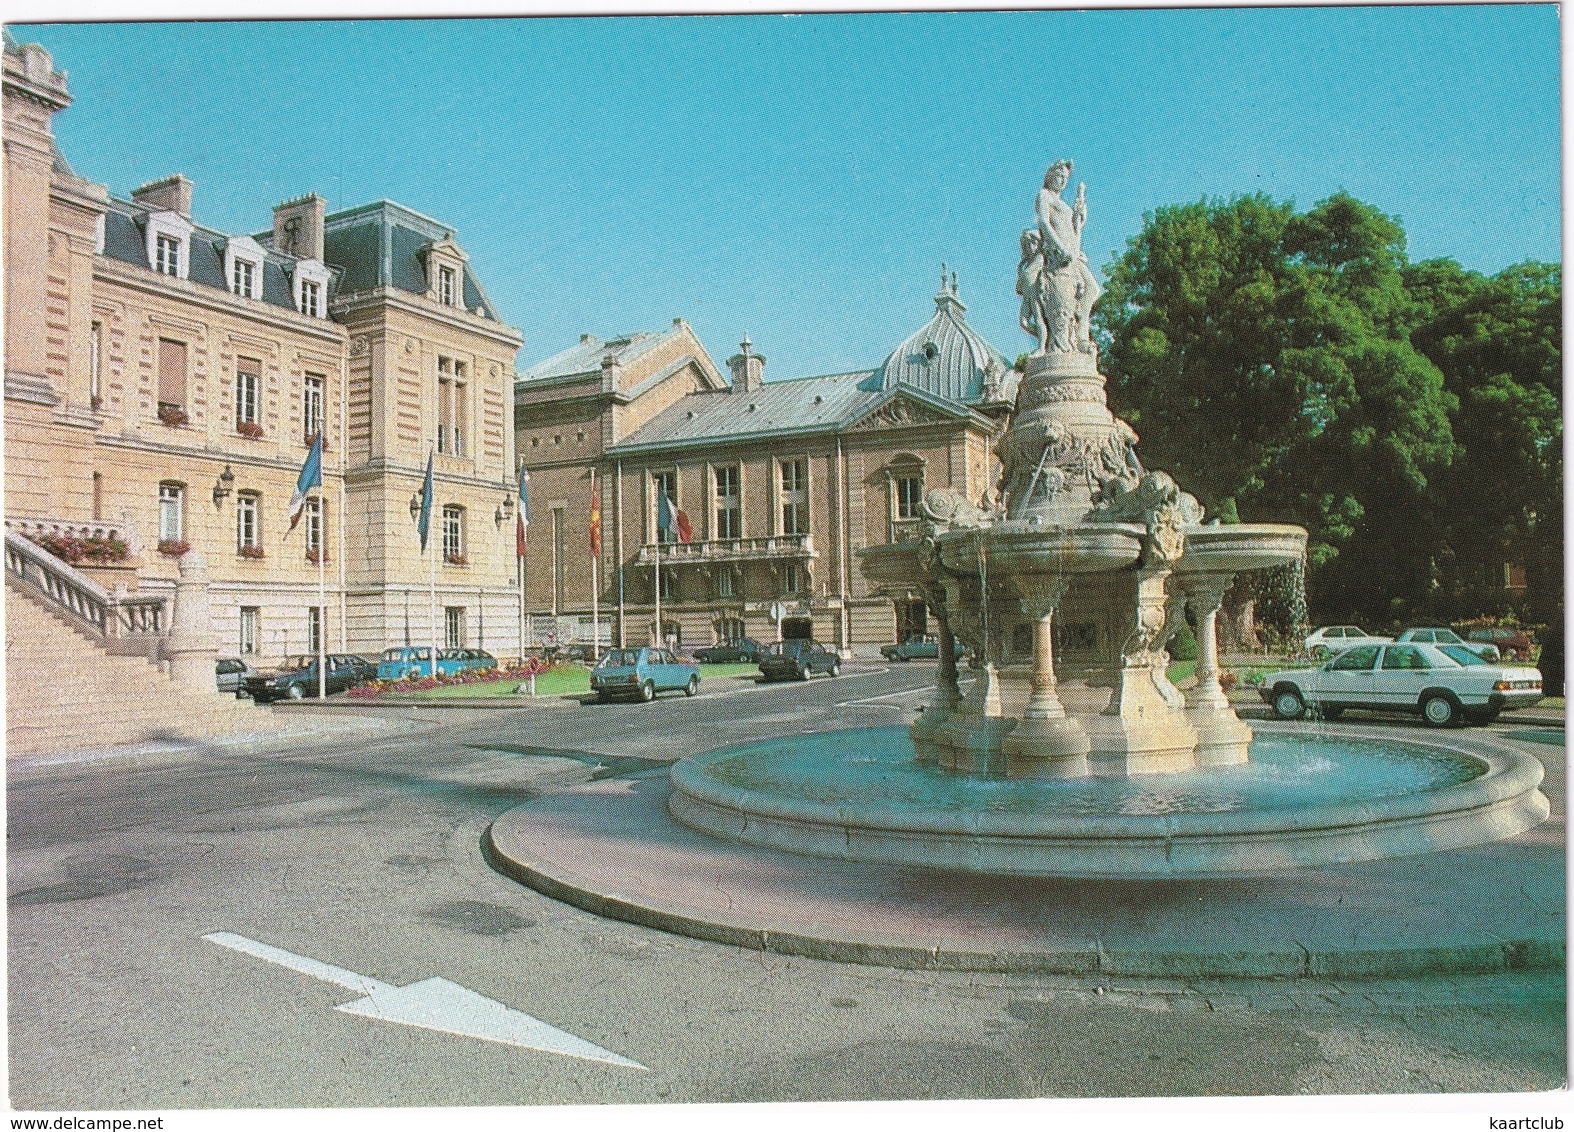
(1097, 194), (1458, 620)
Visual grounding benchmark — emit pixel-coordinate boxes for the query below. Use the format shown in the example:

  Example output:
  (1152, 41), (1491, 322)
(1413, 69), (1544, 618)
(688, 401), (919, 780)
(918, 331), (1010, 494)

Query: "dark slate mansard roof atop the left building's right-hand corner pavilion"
(313, 200), (501, 321)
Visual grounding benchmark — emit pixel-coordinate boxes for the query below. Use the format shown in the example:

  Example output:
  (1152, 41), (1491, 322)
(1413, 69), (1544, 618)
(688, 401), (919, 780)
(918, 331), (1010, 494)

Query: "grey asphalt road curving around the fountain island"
(6, 664), (1566, 1115)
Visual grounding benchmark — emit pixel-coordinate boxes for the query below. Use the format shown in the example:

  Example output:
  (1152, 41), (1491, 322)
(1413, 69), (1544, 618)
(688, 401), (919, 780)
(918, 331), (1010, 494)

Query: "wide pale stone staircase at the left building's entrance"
(5, 576), (285, 757)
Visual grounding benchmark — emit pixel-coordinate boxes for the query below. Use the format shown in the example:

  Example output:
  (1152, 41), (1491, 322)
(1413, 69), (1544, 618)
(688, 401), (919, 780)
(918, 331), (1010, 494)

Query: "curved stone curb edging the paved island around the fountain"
(482, 787), (1566, 979)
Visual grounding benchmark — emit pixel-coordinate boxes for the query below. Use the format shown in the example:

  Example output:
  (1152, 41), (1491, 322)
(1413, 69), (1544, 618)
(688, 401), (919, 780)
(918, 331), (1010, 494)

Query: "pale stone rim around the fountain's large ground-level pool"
(667, 724), (1550, 879)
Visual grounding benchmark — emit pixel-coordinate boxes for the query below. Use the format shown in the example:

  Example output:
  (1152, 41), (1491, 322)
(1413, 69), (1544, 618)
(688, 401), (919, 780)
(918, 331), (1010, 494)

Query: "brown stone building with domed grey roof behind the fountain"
(515, 279), (1017, 652)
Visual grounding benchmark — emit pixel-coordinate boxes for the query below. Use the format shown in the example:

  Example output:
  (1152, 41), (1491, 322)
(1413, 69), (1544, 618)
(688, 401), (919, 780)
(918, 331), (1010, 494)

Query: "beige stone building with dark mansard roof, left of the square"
(3, 35), (519, 663)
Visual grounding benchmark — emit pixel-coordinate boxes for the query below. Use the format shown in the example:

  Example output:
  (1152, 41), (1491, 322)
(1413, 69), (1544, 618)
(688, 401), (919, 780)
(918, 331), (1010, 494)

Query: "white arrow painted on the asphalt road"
(203, 932), (647, 1069)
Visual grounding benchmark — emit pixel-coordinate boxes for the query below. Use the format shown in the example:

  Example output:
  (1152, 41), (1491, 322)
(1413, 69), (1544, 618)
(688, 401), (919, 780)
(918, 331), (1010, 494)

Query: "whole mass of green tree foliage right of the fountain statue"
(1096, 192), (1561, 622)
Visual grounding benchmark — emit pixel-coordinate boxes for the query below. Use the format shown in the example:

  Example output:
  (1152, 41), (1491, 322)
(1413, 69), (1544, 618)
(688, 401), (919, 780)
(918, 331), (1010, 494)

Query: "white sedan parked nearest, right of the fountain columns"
(1261, 642), (1541, 727)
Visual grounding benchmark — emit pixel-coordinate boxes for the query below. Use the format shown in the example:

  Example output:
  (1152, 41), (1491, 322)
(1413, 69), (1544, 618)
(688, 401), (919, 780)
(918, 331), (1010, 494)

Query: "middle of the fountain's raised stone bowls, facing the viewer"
(937, 520), (1144, 576)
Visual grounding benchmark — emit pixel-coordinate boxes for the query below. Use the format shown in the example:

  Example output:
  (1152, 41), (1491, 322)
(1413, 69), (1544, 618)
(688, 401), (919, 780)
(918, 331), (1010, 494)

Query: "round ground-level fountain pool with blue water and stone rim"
(669, 727), (1549, 877)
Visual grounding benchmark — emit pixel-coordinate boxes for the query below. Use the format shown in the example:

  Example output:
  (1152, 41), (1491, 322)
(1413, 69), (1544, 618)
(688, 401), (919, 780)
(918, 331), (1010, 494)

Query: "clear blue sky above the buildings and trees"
(13, 5), (1561, 378)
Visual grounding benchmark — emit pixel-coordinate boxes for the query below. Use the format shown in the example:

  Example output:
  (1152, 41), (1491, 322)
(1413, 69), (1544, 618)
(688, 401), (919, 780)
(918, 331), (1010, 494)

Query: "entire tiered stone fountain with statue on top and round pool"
(669, 162), (1549, 877)
